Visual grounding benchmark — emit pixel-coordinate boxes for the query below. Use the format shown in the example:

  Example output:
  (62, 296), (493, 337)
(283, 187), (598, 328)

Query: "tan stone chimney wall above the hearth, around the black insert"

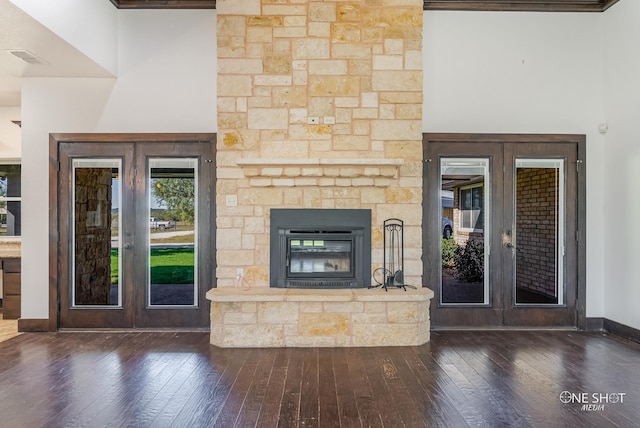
(216, 0), (423, 287)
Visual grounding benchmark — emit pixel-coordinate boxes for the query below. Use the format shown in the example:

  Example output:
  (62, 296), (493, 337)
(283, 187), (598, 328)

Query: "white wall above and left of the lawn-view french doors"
(22, 10), (216, 318)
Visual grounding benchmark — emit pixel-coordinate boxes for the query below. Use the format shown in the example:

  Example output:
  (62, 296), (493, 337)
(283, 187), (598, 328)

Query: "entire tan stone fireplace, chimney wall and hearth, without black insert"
(208, 0), (432, 346)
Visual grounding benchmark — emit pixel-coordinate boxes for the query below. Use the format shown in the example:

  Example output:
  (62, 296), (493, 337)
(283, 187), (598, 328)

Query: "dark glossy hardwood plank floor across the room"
(0, 331), (640, 428)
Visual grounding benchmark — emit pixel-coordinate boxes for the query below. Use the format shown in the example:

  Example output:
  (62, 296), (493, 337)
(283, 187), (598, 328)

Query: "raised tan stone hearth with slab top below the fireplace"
(207, 288), (433, 348)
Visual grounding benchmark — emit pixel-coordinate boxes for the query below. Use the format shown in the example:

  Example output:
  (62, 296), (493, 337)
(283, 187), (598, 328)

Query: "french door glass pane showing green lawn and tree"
(147, 158), (198, 307)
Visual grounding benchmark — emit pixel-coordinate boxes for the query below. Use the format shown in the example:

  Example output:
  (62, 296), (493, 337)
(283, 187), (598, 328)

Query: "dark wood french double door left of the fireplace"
(57, 135), (215, 329)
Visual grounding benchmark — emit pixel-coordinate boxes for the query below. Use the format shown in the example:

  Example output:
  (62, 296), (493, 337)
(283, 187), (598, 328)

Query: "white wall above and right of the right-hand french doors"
(423, 10), (617, 317)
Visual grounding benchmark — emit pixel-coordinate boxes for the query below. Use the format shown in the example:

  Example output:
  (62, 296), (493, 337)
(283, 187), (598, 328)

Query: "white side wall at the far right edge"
(603, 1), (640, 329)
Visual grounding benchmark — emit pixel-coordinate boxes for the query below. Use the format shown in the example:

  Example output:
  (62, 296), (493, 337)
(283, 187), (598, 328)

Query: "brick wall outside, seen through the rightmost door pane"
(516, 168), (558, 296)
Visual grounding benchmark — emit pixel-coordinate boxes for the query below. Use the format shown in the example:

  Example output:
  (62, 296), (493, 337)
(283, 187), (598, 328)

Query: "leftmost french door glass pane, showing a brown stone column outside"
(71, 159), (122, 308)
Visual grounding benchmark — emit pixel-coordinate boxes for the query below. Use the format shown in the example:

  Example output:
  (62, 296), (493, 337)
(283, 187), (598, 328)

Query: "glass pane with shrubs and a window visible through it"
(439, 158), (490, 305)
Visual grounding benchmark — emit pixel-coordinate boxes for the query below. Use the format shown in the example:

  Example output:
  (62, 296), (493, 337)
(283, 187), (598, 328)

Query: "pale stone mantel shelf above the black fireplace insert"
(236, 158), (404, 187)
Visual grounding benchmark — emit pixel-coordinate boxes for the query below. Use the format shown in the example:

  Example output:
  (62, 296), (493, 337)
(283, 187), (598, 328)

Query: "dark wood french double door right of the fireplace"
(424, 134), (584, 328)
